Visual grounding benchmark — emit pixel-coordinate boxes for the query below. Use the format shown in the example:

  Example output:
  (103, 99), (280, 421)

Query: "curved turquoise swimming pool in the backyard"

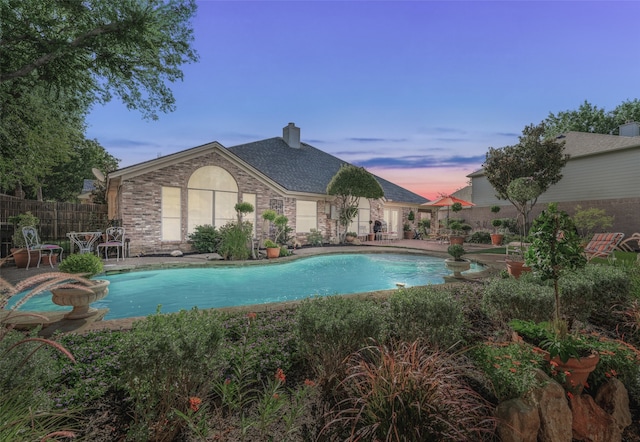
(10, 253), (482, 319)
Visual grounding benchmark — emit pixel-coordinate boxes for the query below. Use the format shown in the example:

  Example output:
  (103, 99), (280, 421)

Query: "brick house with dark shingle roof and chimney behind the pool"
(107, 123), (427, 254)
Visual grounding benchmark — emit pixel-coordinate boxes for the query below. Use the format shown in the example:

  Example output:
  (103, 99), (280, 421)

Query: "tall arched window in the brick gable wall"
(187, 166), (238, 233)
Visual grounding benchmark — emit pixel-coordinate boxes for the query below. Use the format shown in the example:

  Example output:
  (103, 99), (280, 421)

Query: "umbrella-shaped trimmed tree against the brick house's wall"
(327, 164), (384, 242)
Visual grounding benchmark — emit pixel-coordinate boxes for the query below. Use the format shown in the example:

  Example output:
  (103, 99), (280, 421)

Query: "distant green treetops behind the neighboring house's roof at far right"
(544, 99), (640, 137)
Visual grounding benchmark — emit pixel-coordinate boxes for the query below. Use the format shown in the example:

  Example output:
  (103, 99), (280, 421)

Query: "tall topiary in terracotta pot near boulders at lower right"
(525, 203), (599, 387)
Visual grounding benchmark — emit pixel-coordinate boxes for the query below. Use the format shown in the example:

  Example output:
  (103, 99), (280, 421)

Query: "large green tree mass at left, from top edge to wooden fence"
(0, 0), (197, 199)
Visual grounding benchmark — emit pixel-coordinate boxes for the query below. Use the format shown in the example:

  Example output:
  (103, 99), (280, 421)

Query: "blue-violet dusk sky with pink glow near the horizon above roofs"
(87, 0), (640, 199)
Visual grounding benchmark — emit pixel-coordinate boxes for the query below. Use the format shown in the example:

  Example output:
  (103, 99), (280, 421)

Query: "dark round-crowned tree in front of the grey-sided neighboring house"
(483, 122), (569, 235)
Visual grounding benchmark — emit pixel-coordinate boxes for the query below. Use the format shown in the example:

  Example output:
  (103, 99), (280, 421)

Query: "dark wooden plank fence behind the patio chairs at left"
(0, 195), (109, 257)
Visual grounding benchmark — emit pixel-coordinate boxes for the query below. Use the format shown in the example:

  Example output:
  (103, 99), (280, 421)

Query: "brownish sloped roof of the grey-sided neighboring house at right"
(467, 132), (640, 177)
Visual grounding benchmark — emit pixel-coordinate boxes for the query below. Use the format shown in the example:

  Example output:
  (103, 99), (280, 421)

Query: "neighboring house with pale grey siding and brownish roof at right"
(468, 123), (640, 235)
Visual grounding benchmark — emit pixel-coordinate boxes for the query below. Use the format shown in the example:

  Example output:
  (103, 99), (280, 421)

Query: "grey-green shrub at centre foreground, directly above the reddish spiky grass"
(296, 296), (383, 384)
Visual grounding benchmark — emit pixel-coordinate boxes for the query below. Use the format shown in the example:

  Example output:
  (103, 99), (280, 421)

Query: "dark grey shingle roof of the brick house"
(227, 137), (427, 204)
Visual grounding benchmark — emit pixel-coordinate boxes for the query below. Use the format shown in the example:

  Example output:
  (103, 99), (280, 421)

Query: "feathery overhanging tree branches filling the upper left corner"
(0, 0), (197, 118)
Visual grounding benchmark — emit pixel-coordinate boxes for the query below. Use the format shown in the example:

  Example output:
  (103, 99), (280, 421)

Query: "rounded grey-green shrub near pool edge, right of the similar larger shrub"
(388, 286), (464, 349)
